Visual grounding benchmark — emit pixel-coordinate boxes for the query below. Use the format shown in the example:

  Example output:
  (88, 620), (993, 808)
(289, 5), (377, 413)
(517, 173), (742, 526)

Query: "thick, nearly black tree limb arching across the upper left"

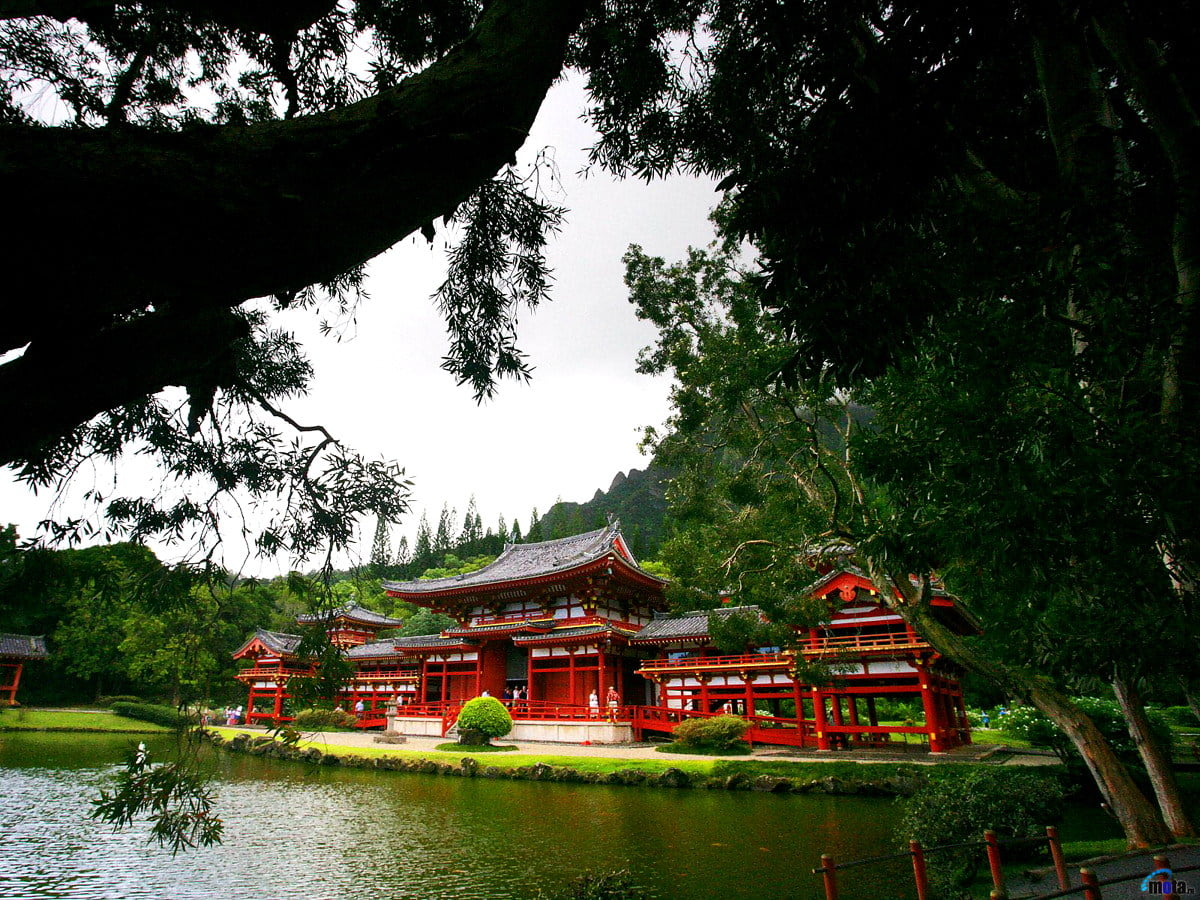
(0, 0), (586, 462)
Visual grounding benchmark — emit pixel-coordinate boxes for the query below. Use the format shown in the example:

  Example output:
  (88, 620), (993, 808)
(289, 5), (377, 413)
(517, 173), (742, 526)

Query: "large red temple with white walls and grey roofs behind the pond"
(236, 524), (978, 752)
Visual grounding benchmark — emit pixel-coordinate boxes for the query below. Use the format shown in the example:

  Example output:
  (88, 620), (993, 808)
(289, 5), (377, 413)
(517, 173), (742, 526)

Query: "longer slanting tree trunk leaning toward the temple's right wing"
(868, 562), (1171, 848)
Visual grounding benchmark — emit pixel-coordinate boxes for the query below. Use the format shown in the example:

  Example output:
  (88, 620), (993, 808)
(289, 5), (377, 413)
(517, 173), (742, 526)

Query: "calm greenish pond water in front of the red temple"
(0, 732), (904, 900)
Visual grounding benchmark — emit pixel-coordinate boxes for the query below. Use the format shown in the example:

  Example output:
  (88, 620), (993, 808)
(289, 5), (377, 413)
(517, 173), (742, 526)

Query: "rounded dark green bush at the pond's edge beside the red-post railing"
(896, 768), (1064, 898)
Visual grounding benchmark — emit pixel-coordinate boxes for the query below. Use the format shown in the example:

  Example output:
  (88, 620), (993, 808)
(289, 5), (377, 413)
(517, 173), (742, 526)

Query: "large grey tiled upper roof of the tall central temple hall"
(383, 522), (666, 594)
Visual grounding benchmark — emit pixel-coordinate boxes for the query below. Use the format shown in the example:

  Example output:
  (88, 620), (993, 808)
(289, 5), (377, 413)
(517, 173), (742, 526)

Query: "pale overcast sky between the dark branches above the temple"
(0, 77), (718, 574)
